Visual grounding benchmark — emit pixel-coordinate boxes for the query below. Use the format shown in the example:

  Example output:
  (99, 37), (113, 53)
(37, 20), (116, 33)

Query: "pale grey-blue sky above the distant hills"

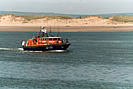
(0, 0), (133, 15)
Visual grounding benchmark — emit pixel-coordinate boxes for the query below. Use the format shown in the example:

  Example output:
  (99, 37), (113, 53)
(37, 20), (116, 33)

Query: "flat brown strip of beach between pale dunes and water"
(0, 26), (133, 32)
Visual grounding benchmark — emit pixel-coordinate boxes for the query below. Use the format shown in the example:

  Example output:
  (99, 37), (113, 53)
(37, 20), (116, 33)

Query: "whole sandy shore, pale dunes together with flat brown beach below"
(0, 14), (133, 32)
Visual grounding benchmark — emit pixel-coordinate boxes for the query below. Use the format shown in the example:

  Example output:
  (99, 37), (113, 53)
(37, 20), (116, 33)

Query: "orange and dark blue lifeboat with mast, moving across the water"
(22, 27), (70, 51)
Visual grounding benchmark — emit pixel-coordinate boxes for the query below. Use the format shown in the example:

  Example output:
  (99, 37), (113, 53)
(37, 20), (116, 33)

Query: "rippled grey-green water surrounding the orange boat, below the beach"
(0, 32), (133, 89)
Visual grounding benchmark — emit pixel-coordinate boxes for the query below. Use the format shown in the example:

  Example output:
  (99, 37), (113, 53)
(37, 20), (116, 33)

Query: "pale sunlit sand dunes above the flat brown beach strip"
(0, 14), (123, 26)
